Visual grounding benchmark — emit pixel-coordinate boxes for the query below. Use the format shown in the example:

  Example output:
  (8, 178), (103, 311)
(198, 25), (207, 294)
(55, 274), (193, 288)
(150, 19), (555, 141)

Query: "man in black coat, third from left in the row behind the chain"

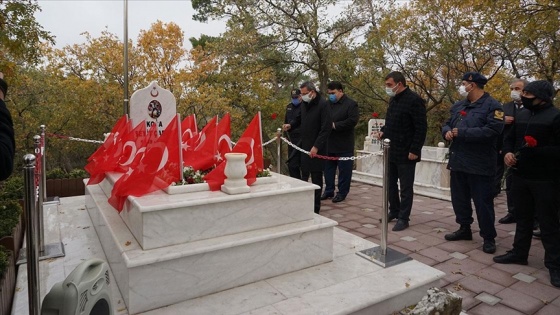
(321, 81), (360, 202)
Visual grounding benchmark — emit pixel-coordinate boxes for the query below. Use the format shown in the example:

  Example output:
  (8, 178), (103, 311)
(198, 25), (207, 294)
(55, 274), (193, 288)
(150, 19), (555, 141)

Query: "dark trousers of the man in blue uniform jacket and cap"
(450, 171), (496, 240)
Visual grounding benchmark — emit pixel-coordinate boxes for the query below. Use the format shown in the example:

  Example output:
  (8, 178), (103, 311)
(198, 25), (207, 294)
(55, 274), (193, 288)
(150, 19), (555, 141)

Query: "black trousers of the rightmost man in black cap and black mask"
(511, 174), (560, 270)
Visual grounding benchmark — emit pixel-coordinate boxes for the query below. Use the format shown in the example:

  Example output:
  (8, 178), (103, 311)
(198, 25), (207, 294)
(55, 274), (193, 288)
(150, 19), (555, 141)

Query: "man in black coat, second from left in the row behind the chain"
(283, 82), (332, 213)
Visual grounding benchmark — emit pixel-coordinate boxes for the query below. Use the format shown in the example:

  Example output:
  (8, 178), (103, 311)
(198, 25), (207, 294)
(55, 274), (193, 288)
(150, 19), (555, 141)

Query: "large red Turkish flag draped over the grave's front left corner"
(109, 116), (182, 212)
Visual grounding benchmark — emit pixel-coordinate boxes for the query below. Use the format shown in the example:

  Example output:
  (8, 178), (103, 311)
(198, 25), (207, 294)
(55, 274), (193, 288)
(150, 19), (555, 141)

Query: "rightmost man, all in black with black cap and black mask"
(494, 80), (560, 287)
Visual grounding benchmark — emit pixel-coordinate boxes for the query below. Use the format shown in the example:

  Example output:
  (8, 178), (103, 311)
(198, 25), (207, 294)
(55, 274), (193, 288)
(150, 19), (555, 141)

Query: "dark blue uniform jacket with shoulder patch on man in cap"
(441, 93), (504, 176)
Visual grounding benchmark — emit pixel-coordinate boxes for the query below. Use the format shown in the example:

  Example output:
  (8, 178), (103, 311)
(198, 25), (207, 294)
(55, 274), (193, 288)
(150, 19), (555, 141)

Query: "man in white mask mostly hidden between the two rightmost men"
(498, 79), (528, 224)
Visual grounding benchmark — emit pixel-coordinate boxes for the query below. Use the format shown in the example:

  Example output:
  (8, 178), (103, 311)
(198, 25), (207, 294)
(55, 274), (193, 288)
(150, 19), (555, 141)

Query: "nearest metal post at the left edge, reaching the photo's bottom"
(23, 154), (41, 315)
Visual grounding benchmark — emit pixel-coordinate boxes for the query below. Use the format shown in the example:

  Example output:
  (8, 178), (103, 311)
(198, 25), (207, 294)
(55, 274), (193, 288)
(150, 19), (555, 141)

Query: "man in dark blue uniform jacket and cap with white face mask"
(442, 72), (504, 254)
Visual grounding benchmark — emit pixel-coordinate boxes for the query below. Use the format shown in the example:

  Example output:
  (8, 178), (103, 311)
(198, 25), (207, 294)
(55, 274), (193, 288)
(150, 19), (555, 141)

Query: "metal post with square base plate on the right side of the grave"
(356, 139), (412, 267)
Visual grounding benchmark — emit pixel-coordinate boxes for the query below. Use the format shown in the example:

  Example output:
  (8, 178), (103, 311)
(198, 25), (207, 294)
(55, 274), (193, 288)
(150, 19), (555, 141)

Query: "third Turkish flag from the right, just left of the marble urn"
(183, 116), (218, 171)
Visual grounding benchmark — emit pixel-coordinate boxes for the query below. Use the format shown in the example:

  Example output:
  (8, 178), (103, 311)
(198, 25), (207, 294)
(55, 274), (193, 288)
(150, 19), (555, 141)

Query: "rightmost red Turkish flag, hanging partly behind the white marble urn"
(204, 112), (264, 190)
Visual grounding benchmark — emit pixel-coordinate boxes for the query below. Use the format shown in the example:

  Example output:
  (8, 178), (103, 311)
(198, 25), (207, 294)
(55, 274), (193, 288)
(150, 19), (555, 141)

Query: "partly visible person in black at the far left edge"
(0, 72), (16, 180)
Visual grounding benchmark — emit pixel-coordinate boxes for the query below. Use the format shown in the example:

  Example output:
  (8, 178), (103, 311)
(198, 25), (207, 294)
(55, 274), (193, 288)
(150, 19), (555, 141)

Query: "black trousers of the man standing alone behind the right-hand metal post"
(387, 162), (416, 221)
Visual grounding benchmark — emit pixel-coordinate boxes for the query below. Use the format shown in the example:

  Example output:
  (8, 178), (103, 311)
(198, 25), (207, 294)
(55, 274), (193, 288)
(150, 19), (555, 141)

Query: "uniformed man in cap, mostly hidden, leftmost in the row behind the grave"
(284, 89), (302, 179)
